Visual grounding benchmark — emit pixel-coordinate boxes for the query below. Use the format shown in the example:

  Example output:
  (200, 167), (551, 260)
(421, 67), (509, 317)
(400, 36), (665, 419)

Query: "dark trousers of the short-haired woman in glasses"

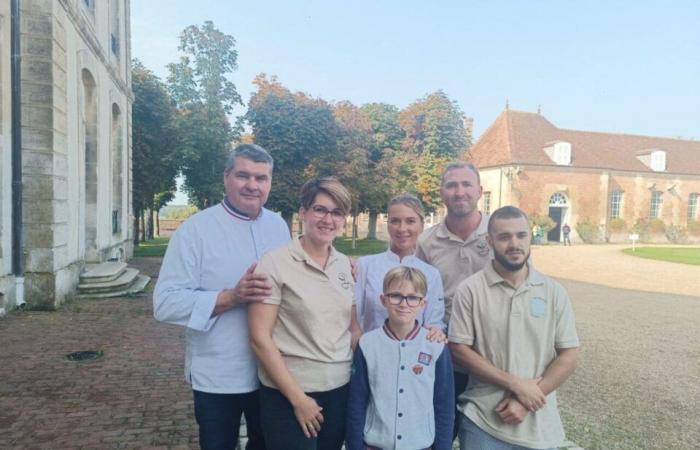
(260, 384), (349, 450)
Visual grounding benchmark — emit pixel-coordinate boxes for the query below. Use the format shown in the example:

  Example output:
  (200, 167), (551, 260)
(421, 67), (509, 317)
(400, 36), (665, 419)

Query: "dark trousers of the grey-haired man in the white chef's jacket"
(192, 390), (266, 450)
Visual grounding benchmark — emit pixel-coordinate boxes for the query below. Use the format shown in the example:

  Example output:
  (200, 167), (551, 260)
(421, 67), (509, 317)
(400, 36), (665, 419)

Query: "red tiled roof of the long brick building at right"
(469, 110), (700, 175)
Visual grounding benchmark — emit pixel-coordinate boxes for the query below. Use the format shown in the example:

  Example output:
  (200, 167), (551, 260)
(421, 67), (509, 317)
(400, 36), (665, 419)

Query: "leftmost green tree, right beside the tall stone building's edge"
(131, 60), (180, 244)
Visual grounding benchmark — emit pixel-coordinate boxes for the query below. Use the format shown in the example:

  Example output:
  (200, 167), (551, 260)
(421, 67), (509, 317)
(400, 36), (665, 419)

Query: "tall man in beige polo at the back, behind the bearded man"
(416, 161), (491, 436)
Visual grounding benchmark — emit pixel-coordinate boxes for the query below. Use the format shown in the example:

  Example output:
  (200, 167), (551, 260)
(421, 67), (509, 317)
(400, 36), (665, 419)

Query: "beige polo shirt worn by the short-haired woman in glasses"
(256, 239), (355, 392)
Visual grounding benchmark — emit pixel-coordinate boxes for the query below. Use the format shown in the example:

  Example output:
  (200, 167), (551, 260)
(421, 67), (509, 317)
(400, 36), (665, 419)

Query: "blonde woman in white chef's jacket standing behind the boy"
(355, 193), (446, 340)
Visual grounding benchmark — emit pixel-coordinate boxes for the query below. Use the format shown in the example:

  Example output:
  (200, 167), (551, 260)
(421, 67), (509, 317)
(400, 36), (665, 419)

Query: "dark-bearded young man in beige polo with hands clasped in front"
(449, 206), (579, 450)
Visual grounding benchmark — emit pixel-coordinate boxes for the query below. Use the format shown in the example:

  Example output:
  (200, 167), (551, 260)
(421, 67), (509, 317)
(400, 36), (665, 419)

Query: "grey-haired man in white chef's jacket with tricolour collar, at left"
(153, 144), (289, 450)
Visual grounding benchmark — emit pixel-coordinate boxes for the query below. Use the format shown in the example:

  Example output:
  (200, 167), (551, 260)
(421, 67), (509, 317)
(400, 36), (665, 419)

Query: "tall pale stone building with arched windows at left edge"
(0, 0), (133, 309)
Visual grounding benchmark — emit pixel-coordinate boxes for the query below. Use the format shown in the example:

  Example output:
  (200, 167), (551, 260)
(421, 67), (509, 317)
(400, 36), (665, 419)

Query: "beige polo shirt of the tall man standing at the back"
(416, 213), (493, 324)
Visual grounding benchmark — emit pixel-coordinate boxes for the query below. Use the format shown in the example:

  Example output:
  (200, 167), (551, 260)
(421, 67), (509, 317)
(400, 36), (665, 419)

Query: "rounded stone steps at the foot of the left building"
(77, 262), (151, 298)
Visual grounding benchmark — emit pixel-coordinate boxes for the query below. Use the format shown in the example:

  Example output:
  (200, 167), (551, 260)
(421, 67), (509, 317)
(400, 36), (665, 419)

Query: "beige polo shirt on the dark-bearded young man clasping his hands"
(449, 264), (579, 448)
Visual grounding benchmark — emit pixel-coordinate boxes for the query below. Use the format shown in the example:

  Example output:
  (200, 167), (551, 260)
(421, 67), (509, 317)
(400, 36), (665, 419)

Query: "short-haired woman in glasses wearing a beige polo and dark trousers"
(248, 178), (359, 450)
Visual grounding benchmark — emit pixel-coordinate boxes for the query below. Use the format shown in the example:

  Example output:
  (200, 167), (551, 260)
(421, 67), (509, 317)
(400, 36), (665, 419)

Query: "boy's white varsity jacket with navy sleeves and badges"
(345, 322), (455, 450)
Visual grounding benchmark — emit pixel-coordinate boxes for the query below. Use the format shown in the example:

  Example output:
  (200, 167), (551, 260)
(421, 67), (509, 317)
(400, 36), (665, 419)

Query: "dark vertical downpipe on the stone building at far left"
(10, 0), (25, 308)
